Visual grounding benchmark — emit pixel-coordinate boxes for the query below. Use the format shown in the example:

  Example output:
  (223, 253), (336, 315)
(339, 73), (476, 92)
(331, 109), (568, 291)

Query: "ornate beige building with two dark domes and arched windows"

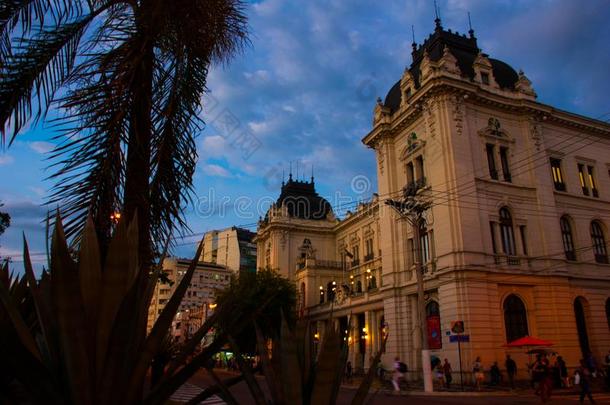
(256, 20), (610, 378)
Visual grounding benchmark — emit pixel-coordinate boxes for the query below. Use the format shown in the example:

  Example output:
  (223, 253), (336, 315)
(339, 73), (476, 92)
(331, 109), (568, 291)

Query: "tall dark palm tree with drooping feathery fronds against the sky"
(0, 0), (247, 271)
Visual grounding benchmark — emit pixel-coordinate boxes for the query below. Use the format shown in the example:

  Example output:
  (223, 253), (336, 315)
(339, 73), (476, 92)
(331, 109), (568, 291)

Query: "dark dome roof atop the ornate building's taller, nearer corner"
(383, 21), (519, 112)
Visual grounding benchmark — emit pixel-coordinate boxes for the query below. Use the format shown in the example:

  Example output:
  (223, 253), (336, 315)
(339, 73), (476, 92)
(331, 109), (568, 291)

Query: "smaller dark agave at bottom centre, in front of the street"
(200, 316), (388, 405)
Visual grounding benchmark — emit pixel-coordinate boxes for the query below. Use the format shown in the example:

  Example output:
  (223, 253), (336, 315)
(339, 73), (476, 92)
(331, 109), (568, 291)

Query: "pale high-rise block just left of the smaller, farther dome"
(201, 226), (256, 273)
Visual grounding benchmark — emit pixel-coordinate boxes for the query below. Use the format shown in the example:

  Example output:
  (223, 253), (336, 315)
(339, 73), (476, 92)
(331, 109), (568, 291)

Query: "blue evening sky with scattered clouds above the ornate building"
(0, 0), (610, 267)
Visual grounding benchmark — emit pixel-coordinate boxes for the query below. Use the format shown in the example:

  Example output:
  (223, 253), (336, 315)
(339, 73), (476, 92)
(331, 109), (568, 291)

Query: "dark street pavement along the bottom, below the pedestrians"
(177, 370), (610, 405)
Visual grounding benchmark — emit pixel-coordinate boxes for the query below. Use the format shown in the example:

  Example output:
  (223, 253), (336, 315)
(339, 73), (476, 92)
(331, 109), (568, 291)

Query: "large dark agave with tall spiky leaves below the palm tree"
(0, 217), (266, 405)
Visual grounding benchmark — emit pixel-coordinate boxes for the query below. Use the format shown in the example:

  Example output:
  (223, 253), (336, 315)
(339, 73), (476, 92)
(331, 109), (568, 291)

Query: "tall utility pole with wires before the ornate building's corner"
(385, 181), (433, 392)
